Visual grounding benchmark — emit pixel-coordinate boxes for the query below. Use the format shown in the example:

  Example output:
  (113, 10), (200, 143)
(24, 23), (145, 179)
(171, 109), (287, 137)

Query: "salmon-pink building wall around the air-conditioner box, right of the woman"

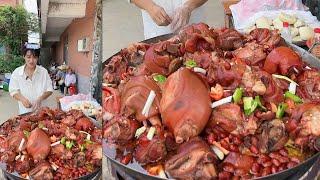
(53, 0), (96, 93)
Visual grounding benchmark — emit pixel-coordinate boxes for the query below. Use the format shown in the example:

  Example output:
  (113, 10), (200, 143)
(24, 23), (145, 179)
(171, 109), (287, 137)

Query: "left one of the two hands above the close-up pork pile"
(147, 3), (171, 26)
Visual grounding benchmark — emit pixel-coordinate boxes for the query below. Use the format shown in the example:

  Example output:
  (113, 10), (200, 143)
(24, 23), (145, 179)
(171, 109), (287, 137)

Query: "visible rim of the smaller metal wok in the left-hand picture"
(0, 113), (102, 180)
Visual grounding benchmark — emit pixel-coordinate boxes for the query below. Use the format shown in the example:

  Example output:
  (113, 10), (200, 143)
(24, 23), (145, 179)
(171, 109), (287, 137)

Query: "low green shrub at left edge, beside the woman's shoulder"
(0, 54), (24, 74)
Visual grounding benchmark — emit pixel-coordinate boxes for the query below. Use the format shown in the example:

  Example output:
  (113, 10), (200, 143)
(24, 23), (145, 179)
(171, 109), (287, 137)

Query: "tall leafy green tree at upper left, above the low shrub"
(0, 6), (39, 55)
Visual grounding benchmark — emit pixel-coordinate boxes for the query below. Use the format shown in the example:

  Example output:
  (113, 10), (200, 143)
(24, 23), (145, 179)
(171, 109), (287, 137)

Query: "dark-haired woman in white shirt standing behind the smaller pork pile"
(9, 44), (53, 114)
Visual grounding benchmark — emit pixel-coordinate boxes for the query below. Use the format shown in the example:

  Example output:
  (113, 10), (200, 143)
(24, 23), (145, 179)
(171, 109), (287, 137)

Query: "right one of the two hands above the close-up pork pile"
(170, 4), (192, 32)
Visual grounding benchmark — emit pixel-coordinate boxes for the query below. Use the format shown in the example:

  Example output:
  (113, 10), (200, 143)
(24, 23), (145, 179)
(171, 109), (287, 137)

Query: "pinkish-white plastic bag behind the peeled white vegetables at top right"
(230, 0), (308, 28)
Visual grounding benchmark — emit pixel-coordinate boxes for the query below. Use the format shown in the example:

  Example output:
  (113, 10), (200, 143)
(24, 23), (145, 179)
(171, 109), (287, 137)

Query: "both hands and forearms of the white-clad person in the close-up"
(132, 0), (207, 32)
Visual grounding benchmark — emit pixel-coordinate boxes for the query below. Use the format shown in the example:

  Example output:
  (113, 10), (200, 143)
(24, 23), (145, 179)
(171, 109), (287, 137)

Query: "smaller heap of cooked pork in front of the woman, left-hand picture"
(0, 108), (102, 180)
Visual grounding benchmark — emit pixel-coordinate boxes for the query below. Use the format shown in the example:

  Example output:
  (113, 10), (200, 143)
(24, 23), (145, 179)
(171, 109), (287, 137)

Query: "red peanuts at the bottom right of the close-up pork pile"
(207, 127), (301, 179)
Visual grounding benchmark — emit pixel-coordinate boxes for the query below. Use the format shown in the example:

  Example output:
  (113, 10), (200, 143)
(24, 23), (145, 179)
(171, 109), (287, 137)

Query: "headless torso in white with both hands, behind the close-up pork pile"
(129, 0), (208, 39)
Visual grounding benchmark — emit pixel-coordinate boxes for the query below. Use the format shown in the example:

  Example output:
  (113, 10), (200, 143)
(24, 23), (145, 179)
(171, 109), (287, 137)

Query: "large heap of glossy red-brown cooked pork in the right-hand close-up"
(103, 23), (320, 179)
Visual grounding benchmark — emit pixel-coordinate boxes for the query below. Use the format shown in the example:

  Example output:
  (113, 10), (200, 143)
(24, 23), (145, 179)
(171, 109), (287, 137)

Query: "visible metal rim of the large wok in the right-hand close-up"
(102, 34), (320, 180)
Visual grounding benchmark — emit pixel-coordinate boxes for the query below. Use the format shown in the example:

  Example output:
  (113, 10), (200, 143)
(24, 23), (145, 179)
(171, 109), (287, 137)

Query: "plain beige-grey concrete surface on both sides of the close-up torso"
(102, 0), (224, 61)
